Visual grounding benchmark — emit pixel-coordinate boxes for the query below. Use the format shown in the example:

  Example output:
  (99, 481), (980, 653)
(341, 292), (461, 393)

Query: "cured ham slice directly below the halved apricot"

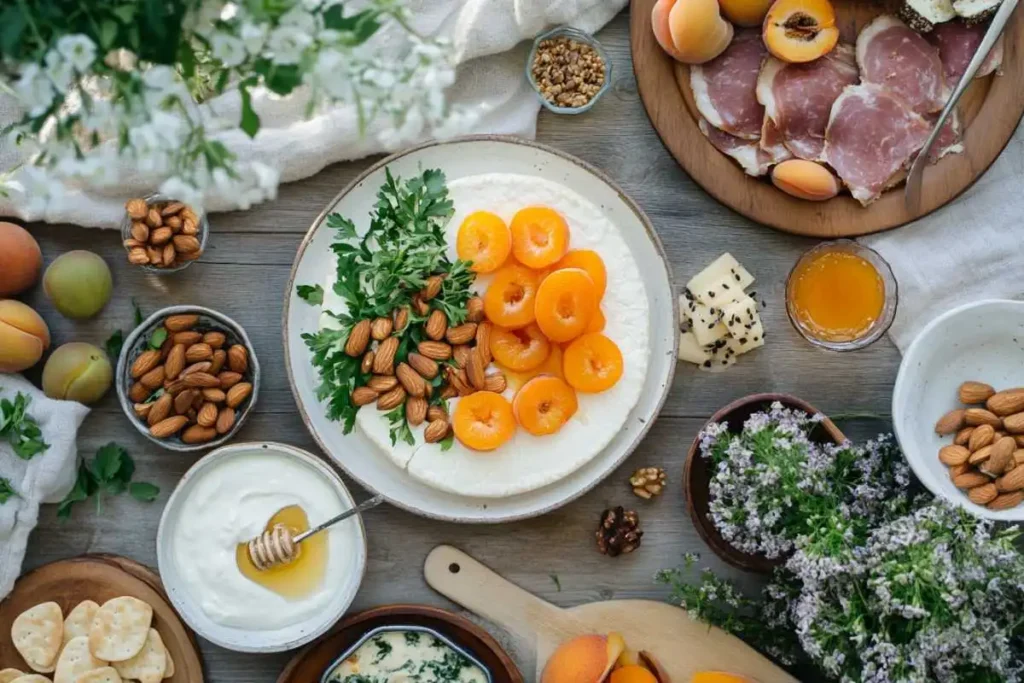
(757, 45), (858, 161)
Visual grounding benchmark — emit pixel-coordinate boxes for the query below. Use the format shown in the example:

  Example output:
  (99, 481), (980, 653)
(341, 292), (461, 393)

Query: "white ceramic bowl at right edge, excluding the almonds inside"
(893, 300), (1024, 521)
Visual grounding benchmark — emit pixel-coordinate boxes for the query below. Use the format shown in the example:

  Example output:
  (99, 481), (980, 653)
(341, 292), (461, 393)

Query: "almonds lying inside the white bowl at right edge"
(935, 382), (1024, 510)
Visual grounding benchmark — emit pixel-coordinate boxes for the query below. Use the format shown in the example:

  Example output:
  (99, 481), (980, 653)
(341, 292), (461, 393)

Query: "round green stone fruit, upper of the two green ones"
(43, 250), (114, 318)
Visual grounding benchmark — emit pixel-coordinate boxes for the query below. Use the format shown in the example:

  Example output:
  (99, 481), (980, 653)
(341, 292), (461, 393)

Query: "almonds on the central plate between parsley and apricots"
(345, 275), (506, 443)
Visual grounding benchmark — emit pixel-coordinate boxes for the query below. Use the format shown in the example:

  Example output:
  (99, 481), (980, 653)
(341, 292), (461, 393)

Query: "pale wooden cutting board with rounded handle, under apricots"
(423, 546), (797, 683)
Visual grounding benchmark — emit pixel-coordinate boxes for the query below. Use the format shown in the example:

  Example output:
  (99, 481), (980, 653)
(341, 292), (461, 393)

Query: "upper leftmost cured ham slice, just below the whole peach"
(690, 30), (768, 143)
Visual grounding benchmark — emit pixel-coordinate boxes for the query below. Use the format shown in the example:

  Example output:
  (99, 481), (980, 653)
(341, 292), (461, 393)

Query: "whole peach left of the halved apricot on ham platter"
(650, 0), (733, 65)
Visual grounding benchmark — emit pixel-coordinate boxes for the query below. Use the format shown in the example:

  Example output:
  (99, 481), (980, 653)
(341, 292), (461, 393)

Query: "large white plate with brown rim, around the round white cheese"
(284, 136), (679, 522)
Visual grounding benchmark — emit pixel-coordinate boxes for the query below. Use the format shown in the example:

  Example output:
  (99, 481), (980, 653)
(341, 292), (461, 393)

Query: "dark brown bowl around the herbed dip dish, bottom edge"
(278, 605), (524, 683)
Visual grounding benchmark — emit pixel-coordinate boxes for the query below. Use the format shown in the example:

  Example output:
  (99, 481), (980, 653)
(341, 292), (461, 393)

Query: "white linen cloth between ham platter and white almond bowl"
(861, 120), (1024, 351)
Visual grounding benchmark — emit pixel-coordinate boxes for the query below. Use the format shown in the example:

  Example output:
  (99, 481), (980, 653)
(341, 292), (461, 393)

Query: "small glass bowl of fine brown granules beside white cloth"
(526, 27), (611, 115)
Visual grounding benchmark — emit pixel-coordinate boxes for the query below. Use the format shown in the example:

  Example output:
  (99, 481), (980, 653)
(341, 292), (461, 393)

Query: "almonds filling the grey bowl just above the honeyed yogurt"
(128, 314), (253, 443)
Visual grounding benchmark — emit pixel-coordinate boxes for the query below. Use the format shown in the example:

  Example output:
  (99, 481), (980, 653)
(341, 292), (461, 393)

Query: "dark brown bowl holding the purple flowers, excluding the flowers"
(683, 393), (846, 573)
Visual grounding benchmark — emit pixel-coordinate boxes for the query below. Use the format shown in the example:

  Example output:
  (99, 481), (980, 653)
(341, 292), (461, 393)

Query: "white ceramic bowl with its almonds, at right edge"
(893, 300), (1024, 521)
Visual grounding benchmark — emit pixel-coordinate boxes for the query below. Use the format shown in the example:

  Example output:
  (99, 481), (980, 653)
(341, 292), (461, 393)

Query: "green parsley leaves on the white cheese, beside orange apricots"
(298, 169), (474, 447)
